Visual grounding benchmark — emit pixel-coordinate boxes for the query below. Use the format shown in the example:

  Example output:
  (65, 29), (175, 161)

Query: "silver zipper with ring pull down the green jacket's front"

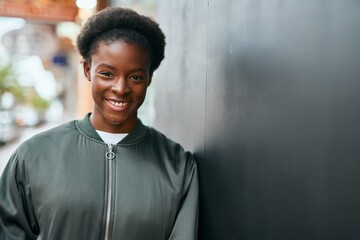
(104, 144), (115, 240)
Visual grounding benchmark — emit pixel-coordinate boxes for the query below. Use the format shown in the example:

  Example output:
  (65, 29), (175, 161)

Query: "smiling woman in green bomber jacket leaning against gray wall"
(0, 8), (198, 240)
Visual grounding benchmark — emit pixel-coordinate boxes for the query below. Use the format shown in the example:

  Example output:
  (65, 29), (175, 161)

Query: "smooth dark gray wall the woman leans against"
(155, 0), (360, 240)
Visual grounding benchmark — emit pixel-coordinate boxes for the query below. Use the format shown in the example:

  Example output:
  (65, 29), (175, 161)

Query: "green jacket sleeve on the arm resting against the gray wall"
(169, 154), (199, 240)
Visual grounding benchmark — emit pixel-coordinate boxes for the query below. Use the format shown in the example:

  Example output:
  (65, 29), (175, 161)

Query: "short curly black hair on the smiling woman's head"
(76, 7), (165, 72)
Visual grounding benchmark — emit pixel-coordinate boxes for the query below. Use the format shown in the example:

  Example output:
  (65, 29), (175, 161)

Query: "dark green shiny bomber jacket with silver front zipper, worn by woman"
(0, 114), (198, 240)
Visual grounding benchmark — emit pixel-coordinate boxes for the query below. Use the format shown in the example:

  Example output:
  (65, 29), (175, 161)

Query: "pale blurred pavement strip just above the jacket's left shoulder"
(0, 124), (58, 176)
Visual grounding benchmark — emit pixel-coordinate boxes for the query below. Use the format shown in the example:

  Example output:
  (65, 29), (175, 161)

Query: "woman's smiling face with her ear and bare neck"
(84, 41), (152, 133)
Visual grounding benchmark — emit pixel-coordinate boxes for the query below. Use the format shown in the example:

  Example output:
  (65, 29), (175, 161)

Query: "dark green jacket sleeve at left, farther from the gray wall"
(0, 153), (37, 240)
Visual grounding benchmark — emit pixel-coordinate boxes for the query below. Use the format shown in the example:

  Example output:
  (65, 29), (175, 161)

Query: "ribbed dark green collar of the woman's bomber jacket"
(76, 113), (149, 144)
